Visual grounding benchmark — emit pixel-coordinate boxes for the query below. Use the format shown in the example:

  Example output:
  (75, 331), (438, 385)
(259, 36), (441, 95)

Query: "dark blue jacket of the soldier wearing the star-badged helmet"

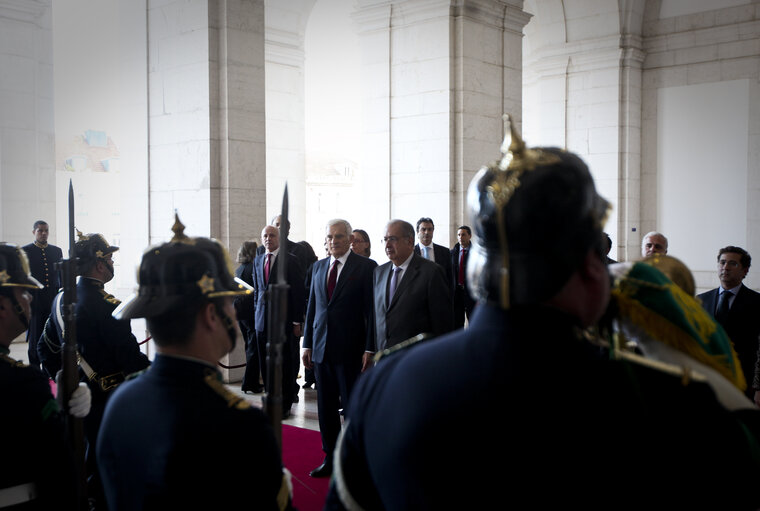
(98, 354), (288, 511)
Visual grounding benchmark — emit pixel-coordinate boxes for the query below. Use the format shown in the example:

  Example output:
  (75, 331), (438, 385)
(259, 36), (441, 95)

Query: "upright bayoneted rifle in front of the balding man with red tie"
(264, 183), (290, 451)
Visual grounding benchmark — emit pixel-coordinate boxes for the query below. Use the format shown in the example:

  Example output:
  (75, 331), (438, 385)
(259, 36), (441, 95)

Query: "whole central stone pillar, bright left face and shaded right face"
(354, 0), (529, 246)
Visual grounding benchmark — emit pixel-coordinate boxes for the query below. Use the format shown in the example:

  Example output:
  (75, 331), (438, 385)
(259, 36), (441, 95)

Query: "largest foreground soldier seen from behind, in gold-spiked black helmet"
(326, 116), (760, 511)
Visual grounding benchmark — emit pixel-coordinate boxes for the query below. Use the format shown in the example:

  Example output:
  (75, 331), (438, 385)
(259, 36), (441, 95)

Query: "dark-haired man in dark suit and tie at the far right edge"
(699, 246), (760, 403)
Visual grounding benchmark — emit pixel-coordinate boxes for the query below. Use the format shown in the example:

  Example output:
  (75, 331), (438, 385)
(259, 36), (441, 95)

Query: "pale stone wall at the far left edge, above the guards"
(0, 0), (55, 244)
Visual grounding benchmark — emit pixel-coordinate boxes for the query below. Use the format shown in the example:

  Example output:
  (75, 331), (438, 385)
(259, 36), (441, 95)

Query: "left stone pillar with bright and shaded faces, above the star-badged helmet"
(148, 0), (266, 381)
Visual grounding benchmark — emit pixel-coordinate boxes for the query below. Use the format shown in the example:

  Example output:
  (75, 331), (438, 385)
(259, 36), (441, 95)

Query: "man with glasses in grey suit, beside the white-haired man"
(373, 220), (453, 351)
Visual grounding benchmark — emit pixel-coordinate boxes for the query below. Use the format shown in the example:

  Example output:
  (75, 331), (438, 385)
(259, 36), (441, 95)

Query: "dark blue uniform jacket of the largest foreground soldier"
(325, 304), (760, 511)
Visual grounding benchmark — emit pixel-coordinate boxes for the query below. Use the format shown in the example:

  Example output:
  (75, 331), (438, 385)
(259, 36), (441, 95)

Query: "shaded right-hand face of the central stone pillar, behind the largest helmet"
(449, 0), (530, 240)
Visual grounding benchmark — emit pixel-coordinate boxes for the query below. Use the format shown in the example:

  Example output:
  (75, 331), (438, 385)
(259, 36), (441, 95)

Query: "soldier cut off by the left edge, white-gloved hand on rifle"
(0, 243), (90, 510)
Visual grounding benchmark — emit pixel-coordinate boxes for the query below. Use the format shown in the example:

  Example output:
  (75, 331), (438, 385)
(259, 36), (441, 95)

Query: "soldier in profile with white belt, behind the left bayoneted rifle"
(37, 232), (150, 509)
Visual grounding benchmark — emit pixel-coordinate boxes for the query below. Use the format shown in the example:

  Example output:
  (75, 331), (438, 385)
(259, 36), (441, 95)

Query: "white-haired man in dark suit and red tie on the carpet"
(303, 219), (377, 477)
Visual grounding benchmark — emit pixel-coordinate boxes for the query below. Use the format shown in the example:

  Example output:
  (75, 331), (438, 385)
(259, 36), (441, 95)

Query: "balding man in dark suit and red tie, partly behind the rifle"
(253, 225), (306, 419)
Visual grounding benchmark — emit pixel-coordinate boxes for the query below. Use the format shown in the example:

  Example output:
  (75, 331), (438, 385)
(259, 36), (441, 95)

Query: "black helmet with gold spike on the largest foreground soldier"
(467, 115), (610, 309)
